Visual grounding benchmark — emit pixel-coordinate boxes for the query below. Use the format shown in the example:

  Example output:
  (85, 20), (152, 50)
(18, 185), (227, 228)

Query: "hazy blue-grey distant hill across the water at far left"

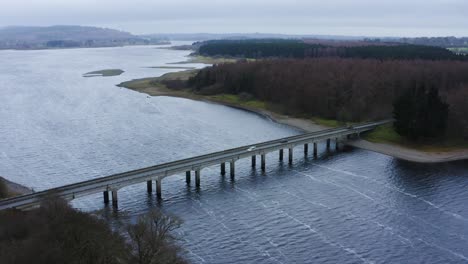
(0, 26), (166, 49)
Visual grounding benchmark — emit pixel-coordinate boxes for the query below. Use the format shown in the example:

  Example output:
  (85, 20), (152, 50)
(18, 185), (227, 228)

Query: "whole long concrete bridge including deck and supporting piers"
(0, 120), (392, 210)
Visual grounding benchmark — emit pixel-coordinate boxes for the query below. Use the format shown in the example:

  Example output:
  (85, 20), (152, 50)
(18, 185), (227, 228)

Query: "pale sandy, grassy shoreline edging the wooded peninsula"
(118, 71), (468, 163)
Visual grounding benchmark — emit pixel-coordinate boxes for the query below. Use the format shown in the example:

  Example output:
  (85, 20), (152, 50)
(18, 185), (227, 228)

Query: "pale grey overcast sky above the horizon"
(0, 0), (468, 36)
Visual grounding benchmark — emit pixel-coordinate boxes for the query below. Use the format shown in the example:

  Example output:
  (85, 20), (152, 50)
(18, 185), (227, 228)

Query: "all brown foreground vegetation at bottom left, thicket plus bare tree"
(0, 197), (185, 264)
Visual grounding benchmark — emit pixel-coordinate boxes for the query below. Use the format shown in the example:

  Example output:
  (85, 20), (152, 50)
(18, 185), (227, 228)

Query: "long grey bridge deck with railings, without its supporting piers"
(0, 119), (392, 210)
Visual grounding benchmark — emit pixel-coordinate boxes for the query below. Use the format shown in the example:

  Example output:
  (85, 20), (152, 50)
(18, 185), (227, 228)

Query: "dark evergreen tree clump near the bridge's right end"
(393, 85), (448, 140)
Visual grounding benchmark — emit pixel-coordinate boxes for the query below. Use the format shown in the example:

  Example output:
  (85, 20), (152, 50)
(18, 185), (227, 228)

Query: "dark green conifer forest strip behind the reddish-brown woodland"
(198, 39), (468, 60)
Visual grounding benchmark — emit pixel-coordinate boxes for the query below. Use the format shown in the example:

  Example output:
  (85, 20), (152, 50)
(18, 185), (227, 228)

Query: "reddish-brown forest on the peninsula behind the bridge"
(188, 58), (468, 137)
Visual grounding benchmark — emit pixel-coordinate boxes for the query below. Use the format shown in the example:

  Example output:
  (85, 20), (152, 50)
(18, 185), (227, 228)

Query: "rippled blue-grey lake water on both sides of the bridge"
(0, 44), (468, 263)
